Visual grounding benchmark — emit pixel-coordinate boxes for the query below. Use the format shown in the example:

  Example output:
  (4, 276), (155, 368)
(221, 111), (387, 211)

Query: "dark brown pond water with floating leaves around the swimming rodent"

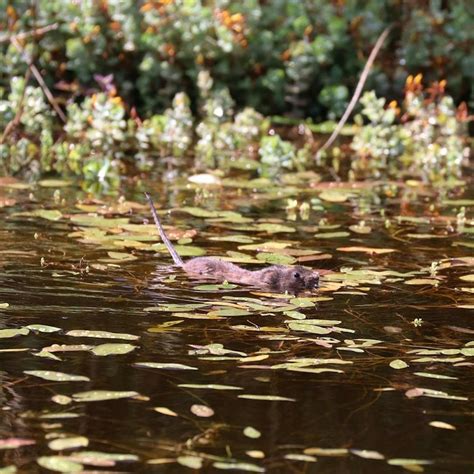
(0, 175), (474, 473)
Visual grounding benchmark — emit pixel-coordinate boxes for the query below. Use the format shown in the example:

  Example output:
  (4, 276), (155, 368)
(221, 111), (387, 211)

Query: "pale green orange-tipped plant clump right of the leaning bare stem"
(352, 75), (468, 182)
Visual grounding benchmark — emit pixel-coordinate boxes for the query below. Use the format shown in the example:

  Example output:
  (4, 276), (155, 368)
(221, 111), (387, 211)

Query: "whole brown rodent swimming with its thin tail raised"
(145, 193), (319, 294)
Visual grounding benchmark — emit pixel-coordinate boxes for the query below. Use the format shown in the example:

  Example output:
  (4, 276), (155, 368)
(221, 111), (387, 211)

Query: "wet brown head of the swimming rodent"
(268, 265), (319, 295)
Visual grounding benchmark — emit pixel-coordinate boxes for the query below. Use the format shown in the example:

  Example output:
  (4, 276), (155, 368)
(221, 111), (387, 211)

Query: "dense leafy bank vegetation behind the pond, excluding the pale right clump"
(0, 0), (474, 187)
